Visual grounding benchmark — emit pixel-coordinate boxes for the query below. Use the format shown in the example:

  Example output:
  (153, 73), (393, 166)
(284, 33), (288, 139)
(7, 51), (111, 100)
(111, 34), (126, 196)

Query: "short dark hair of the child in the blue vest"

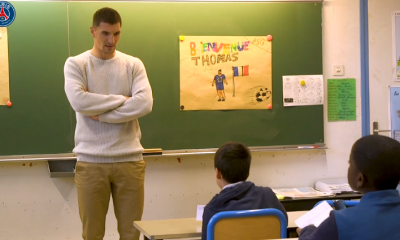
(351, 135), (400, 190)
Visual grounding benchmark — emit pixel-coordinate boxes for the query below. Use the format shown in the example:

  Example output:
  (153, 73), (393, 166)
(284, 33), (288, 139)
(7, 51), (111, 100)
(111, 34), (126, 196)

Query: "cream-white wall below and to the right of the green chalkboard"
(0, 0), (362, 240)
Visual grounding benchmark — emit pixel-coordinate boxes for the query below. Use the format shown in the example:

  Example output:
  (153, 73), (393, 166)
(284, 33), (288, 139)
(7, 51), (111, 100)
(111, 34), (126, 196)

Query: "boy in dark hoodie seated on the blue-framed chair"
(201, 142), (287, 240)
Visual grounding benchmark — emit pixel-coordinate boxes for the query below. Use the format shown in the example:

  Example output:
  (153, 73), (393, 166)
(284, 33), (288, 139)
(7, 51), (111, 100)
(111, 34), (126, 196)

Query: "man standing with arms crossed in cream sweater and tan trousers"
(64, 8), (153, 240)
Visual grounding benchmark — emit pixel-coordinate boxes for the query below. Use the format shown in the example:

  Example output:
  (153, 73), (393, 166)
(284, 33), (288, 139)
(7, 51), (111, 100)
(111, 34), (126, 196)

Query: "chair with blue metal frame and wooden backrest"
(207, 208), (287, 240)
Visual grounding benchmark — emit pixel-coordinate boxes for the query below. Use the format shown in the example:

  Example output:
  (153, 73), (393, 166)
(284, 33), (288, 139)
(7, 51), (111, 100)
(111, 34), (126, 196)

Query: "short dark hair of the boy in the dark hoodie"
(214, 142), (251, 183)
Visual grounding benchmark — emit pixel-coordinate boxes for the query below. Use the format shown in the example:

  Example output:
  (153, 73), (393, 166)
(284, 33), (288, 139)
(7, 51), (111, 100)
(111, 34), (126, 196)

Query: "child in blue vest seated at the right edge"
(297, 135), (400, 240)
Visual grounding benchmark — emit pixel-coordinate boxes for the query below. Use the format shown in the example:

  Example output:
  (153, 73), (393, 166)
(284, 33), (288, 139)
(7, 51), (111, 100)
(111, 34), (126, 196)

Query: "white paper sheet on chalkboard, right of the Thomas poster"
(282, 75), (324, 107)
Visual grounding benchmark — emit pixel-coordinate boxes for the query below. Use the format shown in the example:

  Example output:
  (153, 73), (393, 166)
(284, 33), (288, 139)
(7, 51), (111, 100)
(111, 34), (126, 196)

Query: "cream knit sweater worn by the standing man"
(64, 51), (153, 162)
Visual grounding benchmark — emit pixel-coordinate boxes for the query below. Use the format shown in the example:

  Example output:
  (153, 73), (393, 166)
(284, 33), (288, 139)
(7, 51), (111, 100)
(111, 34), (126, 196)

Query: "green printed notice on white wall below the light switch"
(328, 78), (356, 122)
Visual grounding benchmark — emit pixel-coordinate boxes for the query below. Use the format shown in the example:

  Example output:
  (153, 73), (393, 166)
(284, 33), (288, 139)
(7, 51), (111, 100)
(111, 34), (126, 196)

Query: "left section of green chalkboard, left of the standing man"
(0, 2), (74, 155)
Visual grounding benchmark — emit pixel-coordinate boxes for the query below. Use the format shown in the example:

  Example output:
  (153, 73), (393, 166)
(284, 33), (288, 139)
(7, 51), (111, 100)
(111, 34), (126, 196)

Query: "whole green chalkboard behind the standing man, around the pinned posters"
(0, 2), (324, 155)
